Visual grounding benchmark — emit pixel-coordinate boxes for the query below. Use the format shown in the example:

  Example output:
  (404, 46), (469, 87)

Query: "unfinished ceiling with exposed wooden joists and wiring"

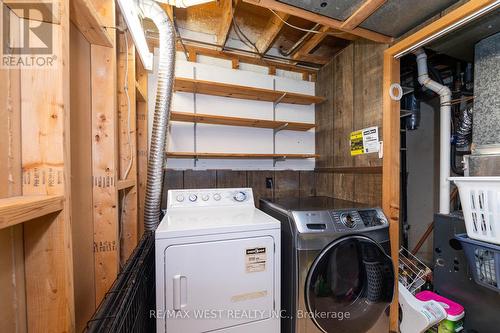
(145, 0), (457, 71)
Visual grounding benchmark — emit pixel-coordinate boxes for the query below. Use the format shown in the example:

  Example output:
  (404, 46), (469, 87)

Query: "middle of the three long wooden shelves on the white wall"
(170, 111), (315, 131)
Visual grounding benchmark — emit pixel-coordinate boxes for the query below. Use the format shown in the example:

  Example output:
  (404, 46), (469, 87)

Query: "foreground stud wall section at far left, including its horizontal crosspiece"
(0, 0), (74, 332)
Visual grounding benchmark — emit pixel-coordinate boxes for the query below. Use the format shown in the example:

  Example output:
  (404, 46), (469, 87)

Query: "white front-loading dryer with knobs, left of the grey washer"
(155, 188), (281, 333)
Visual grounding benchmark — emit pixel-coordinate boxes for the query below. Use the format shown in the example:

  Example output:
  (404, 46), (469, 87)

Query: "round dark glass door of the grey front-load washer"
(305, 236), (394, 333)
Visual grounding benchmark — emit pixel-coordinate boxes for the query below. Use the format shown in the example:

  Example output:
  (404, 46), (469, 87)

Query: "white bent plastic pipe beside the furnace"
(414, 49), (451, 214)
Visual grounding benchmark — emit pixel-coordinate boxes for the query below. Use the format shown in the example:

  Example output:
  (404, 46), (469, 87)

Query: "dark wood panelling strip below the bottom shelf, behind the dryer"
(162, 170), (316, 209)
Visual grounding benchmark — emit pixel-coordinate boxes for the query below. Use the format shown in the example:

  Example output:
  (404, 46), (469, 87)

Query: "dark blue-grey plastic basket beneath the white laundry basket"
(455, 234), (500, 292)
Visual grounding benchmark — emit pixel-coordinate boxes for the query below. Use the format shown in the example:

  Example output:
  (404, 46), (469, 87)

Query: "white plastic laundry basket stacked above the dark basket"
(450, 177), (500, 245)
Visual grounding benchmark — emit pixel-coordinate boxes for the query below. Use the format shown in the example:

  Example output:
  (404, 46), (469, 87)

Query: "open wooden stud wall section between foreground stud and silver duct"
(70, 0), (147, 331)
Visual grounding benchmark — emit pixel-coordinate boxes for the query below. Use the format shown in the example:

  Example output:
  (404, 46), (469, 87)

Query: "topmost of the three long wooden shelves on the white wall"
(174, 77), (325, 105)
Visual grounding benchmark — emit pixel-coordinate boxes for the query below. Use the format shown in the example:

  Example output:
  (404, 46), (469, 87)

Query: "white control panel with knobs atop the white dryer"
(167, 188), (255, 209)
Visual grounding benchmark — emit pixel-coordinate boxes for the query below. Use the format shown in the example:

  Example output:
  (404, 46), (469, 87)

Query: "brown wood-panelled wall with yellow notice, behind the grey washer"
(315, 41), (386, 206)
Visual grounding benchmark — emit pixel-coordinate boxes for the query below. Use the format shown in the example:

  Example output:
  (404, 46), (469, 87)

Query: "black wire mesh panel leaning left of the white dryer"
(86, 233), (156, 333)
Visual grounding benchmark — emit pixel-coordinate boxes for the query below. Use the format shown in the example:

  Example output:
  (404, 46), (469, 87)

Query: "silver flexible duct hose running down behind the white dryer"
(141, 0), (175, 231)
